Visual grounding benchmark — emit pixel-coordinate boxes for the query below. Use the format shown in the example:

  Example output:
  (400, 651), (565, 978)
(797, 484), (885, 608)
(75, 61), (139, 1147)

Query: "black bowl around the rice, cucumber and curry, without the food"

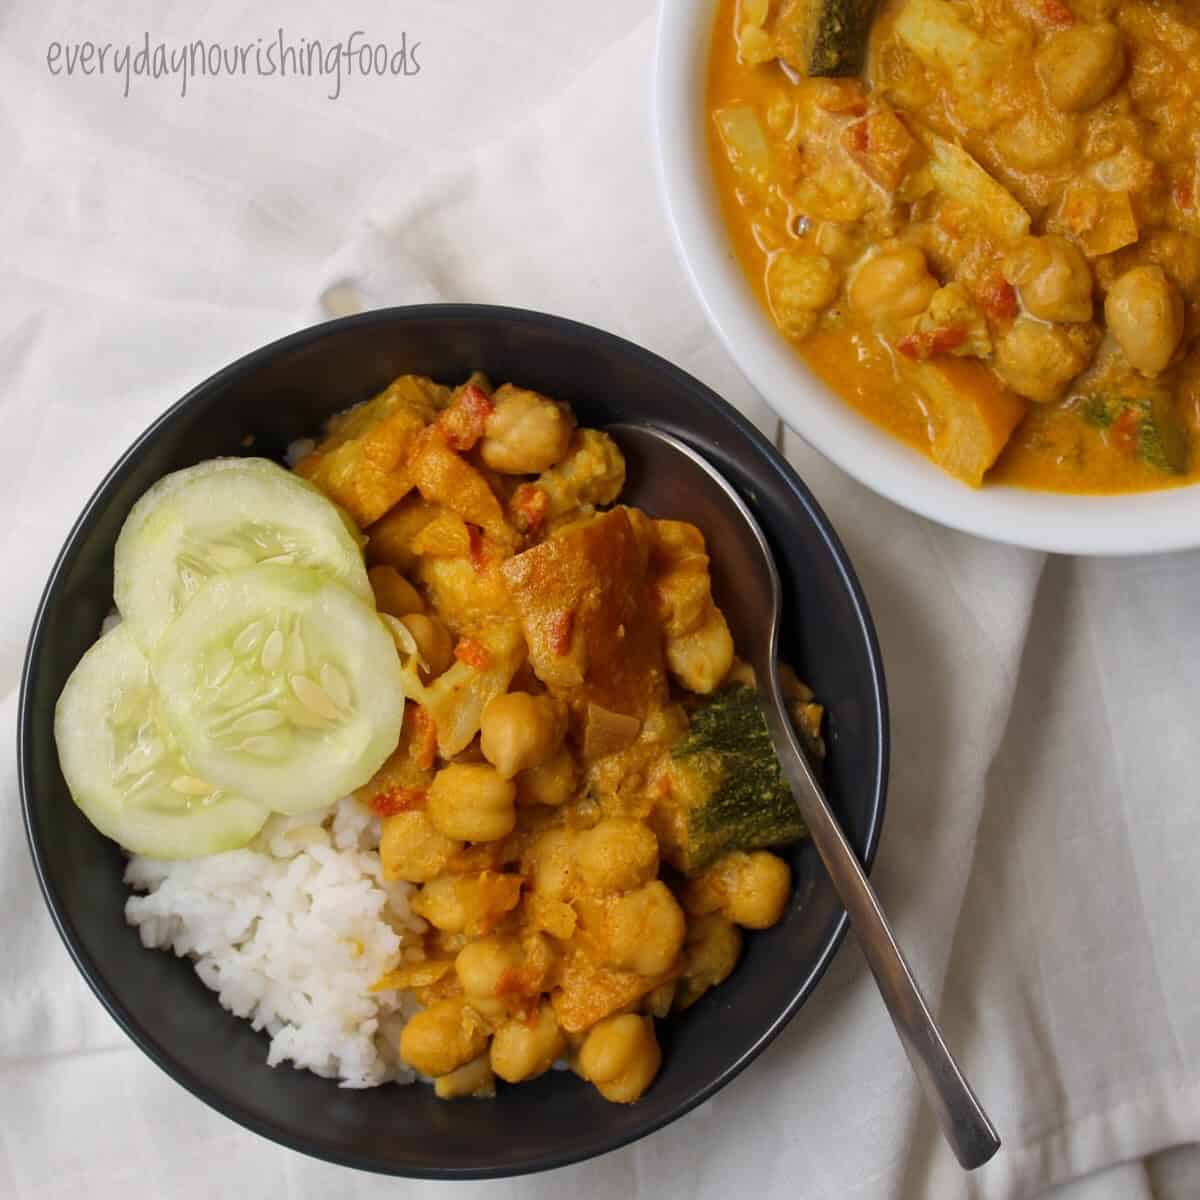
(18, 305), (888, 1178)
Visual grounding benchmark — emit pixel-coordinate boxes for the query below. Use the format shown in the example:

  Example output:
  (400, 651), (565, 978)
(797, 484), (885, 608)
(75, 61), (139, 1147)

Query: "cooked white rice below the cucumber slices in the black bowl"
(125, 797), (426, 1087)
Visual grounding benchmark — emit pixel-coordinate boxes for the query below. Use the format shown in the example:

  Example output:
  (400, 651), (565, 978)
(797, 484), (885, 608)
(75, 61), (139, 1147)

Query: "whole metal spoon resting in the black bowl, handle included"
(608, 425), (1000, 1170)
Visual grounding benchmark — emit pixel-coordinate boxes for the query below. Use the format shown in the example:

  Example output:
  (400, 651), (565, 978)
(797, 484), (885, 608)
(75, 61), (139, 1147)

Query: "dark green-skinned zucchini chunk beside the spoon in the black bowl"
(671, 684), (806, 875)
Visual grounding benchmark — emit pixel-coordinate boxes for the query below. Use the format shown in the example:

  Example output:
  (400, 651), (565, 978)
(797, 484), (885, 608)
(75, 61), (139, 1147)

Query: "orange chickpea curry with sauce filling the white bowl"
(707, 0), (1200, 492)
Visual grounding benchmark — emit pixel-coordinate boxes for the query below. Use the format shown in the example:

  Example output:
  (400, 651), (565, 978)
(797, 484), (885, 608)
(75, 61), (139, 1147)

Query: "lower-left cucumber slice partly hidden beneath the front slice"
(54, 622), (270, 858)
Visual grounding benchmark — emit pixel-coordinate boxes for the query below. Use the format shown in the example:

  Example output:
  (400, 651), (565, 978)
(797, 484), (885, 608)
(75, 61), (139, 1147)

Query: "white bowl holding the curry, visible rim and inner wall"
(654, 0), (1200, 554)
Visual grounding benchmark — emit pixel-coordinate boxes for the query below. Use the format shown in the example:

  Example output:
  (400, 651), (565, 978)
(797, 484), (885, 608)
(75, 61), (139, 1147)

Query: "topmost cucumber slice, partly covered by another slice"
(113, 458), (374, 654)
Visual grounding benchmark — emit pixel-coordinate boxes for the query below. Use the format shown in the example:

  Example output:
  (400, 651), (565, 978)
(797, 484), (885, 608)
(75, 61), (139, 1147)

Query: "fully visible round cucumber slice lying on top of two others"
(152, 564), (404, 812)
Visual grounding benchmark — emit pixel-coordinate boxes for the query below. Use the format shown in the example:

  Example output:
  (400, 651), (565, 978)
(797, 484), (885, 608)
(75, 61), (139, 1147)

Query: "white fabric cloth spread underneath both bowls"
(0, 0), (1200, 1200)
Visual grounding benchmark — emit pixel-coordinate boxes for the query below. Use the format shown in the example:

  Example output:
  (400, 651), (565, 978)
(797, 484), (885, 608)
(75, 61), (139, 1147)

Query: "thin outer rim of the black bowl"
(17, 304), (890, 1180)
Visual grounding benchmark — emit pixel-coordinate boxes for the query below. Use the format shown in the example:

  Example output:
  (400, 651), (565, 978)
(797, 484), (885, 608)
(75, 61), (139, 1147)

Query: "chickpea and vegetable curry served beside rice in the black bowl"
(295, 374), (823, 1103)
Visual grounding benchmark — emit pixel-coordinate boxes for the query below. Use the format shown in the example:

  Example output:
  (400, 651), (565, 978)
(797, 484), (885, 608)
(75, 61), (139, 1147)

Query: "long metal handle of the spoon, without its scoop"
(763, 664), (1000, 1171)
